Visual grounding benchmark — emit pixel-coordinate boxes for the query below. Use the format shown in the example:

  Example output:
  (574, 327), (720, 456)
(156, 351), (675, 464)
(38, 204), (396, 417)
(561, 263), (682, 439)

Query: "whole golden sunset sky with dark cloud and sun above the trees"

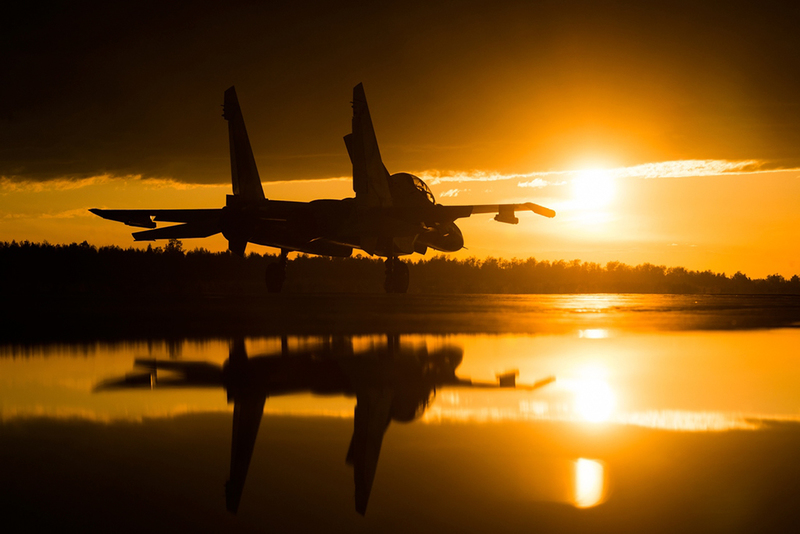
(0, 0), (800, 277)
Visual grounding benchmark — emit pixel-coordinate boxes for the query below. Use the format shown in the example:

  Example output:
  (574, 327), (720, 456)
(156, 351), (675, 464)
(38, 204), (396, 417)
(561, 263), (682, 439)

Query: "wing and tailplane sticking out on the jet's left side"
(89, 208), (222, 241)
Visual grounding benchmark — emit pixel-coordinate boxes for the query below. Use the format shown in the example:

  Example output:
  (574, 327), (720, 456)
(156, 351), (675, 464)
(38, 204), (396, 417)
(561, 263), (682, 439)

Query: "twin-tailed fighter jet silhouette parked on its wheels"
(89, 84), (555, 293)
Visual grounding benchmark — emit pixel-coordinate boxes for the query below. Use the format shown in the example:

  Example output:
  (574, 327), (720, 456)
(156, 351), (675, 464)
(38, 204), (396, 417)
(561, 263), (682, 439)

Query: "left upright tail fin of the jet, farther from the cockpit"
(222, 87), (264, 200)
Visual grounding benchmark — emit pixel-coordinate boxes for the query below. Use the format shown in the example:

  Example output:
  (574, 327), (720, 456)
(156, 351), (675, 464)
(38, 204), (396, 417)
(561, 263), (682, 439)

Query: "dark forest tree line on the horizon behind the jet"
(0, 239), (800, 298)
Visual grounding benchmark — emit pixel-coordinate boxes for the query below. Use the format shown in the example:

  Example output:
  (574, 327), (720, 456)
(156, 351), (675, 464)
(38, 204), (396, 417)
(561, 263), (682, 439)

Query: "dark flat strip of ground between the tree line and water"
(0, 293), (800, 343)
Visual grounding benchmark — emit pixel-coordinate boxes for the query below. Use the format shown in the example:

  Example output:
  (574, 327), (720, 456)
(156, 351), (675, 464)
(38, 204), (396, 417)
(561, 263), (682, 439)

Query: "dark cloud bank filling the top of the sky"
(0, 0), (800, 183)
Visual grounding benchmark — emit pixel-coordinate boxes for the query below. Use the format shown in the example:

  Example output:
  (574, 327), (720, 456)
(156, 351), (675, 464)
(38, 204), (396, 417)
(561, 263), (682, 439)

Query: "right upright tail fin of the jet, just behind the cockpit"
(344, 84), (392, 207)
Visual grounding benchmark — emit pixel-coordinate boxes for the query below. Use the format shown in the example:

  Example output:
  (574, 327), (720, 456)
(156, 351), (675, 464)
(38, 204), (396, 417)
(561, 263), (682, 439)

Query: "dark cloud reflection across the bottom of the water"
(0, 414), (800, 532)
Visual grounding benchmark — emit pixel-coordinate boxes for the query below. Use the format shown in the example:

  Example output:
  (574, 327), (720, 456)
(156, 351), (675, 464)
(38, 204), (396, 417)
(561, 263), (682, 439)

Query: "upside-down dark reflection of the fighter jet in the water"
(95, 337), (555, 515)
